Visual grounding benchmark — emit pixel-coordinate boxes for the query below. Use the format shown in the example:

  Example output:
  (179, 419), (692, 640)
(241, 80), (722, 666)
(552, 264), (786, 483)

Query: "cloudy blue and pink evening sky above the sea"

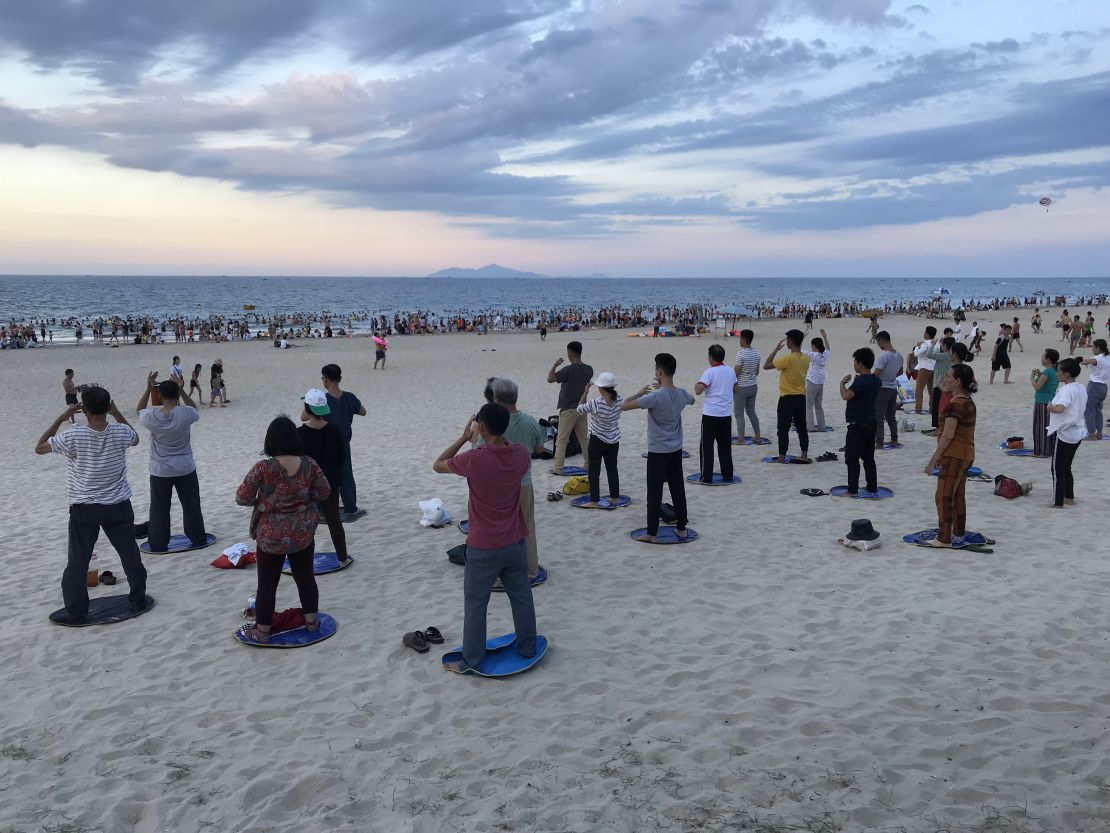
(0, 0), (1110, 278)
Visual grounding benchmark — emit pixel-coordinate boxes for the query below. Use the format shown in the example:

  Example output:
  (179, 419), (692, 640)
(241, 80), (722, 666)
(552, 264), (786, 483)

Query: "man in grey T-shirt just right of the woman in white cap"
(620, 353), (694, 543)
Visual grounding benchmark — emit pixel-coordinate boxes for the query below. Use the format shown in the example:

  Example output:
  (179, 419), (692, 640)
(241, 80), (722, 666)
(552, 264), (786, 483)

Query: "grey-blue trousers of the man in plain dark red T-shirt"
(463, 539), (536, 668)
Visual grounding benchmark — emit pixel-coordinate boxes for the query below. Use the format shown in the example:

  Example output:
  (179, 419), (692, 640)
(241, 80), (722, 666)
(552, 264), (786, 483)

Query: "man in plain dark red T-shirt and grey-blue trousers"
(432, 402), (536, 668)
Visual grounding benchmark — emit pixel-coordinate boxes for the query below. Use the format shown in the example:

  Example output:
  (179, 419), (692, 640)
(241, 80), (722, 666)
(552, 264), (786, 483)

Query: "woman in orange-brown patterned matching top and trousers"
(925, 364), (977, 548)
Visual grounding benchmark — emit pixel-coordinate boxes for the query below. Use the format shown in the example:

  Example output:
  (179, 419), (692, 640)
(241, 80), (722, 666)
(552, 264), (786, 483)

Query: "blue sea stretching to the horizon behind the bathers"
(0, 275), (1110, 337)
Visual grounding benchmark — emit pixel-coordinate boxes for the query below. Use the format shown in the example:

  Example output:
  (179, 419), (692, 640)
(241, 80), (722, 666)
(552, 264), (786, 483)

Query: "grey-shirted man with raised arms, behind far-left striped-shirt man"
(135, 371), (208, 552)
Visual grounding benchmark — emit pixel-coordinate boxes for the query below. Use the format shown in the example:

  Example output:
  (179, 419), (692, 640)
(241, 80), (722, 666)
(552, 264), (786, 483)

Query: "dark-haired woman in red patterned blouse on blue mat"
(235, 417), (331, 643)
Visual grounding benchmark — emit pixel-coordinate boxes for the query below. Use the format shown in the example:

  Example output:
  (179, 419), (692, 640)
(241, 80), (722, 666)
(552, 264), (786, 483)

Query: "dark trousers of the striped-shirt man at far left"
(62, 500), (147, 619)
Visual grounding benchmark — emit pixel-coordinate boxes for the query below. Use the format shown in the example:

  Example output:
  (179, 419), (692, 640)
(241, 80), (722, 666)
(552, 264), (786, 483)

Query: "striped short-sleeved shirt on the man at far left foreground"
(50, 422), (139, 504)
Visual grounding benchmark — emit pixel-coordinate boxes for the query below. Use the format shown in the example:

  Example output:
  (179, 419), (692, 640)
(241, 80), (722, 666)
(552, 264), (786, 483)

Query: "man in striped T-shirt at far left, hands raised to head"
(34, 388), (147, 623)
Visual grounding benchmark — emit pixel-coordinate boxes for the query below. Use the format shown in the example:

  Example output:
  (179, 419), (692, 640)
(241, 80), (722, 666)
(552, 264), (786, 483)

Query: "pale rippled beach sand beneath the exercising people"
(0, 313), (1110, 833)
